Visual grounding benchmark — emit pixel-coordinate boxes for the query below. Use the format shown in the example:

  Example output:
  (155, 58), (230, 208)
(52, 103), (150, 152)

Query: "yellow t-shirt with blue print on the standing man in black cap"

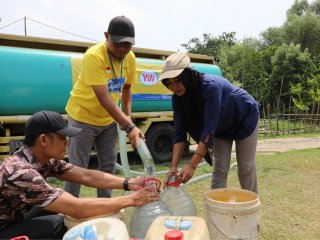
(66, 42), (136, 126)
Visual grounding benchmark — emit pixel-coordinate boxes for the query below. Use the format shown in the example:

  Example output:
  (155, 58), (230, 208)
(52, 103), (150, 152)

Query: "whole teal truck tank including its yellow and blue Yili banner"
(0, 46), (221, 116)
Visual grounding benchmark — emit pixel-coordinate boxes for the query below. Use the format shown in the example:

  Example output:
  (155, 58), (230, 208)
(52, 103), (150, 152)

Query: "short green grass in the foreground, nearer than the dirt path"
(52, 149), (320, 240)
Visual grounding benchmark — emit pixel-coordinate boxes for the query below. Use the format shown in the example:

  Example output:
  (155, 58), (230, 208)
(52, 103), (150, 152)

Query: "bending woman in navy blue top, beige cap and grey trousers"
(159, 52), (259, 193)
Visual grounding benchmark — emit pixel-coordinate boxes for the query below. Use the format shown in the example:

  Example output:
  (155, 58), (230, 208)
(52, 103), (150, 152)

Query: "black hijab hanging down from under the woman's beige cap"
(162, 67), (212, 166)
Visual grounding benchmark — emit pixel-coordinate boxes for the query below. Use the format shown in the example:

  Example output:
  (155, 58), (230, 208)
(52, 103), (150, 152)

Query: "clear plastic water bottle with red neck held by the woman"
(161, 176), (197, 216)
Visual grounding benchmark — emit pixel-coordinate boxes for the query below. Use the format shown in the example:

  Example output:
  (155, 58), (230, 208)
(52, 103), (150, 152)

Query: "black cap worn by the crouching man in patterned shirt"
(25, 111), (82, 137)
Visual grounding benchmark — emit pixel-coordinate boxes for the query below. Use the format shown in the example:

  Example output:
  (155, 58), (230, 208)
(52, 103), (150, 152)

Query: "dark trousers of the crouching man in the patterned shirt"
(0, 207), (67, 239)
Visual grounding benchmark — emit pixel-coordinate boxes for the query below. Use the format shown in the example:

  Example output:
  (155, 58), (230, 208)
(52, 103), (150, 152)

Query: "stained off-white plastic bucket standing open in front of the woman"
(204, 188), (260, 240)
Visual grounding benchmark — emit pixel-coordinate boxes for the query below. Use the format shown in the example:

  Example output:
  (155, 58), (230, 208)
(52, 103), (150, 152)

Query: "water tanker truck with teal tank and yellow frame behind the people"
(0, 34), (221, 163)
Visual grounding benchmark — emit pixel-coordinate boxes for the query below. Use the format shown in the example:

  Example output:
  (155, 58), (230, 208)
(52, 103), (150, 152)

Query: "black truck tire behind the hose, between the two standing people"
(146, 123), (174, 163)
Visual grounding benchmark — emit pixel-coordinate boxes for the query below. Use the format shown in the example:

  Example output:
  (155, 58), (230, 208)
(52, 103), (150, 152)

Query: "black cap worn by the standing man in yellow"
(108, 16), (135, 44)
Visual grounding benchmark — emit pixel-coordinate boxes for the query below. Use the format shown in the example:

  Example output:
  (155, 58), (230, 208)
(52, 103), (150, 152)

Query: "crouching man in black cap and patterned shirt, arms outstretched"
(0, 111), (159, 239)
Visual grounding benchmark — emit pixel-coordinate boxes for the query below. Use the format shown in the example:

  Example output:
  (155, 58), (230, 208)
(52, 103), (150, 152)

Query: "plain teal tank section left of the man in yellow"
(0, 47), (80, 115)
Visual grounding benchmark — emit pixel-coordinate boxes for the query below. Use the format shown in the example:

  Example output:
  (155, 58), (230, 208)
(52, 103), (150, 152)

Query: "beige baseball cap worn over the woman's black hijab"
(159, 52), (190, 81)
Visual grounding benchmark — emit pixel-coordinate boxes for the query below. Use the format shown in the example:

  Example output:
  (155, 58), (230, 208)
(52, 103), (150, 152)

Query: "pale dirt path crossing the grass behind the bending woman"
(190, 137), (320, 154)
